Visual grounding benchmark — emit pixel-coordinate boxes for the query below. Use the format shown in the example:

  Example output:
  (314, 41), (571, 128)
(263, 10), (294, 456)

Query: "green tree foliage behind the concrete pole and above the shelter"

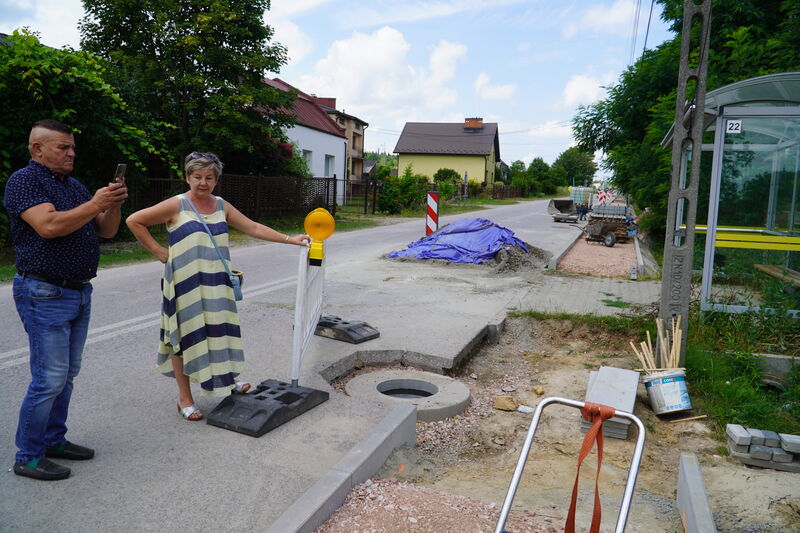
(572, 0), (800, 237)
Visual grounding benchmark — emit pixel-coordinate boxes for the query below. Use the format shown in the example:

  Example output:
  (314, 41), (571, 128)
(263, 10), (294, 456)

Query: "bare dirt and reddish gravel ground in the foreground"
(318, 235), (800, 533)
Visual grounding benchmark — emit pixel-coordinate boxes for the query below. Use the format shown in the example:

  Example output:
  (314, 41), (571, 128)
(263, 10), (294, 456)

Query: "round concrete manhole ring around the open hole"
(344, 370), (469, 422)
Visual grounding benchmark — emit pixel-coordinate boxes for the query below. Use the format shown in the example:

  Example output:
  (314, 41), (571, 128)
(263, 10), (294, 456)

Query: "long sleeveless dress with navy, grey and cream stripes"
(158, 195), (244, 394)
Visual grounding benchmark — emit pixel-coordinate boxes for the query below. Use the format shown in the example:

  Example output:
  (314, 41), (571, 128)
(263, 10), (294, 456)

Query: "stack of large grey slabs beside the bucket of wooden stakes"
(581, 366), (639, 440)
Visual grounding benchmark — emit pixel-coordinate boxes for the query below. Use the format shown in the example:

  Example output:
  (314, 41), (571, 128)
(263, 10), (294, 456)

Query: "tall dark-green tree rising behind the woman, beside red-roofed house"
(80, 0), (295, 172)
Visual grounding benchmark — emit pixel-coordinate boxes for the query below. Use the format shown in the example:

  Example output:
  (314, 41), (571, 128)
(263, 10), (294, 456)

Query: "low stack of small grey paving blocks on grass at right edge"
(725, 424), (800, 472)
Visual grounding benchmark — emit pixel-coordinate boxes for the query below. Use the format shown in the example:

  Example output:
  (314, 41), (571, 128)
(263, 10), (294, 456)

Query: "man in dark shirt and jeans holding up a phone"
(4, 120), (128, 480)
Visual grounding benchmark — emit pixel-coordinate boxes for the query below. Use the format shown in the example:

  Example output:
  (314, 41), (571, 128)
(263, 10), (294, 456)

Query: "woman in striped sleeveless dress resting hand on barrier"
(127, 152), (310, 420)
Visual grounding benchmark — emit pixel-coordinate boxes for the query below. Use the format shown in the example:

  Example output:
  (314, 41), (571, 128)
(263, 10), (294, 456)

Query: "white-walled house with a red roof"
(264, 78), (348, 179)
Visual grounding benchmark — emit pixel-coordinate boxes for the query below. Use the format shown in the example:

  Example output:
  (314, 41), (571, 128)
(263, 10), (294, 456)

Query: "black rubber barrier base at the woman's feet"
(206, 379), (330, 437)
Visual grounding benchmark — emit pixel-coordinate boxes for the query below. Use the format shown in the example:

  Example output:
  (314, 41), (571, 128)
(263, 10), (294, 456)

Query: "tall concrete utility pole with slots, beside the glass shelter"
(656, 0), (711, 366)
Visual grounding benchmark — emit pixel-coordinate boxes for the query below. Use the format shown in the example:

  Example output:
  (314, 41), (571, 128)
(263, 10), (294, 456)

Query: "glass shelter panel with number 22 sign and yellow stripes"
(695, 108), (800, 314)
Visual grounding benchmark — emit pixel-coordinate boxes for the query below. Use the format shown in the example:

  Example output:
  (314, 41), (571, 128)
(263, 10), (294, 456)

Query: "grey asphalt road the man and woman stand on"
(0, 197), (579, 532)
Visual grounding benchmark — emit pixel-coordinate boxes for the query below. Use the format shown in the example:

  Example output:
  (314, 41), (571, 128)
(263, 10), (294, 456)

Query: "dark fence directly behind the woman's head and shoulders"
(129, 174), (336, 220)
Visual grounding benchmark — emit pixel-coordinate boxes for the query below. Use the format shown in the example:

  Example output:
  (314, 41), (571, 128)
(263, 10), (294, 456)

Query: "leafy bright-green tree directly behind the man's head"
(0, 30), (171, 244)
